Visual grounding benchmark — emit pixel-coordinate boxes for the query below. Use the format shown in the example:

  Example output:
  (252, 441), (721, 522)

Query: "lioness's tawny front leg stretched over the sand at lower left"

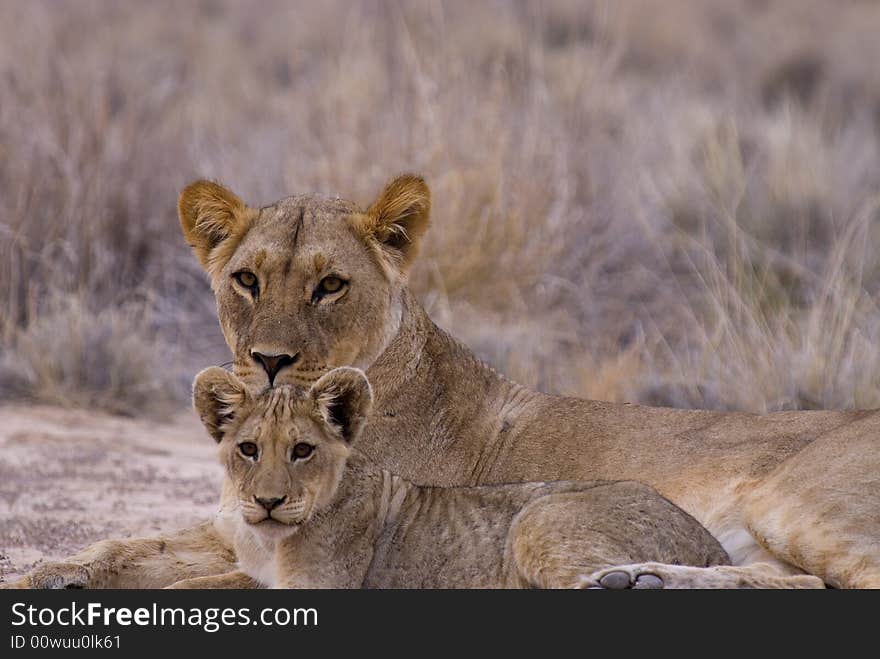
(2, 522), (236, 589)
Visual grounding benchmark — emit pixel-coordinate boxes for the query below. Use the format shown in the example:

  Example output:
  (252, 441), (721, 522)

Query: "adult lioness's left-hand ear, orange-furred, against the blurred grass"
(177, 180), (256, 272)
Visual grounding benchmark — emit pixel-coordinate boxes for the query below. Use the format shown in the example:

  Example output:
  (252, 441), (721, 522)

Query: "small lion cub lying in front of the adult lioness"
(189, 367), (727, 588)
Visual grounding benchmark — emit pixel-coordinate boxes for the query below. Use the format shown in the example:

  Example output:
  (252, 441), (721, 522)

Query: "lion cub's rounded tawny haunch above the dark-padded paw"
(506, 481), (730, 588)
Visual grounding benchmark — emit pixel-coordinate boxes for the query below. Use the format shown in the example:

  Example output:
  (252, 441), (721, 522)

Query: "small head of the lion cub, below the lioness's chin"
(193, 366), (372, 533)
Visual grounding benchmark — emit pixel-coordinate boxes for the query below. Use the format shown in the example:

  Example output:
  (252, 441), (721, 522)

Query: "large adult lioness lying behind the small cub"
(5, 176), (880, 587)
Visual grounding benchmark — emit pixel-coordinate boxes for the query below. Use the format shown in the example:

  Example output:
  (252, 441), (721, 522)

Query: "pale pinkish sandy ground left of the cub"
(0, 405), (221, 581)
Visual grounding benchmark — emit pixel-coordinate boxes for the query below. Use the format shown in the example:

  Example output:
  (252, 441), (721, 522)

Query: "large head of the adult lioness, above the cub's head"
(178, 176), (431, 389)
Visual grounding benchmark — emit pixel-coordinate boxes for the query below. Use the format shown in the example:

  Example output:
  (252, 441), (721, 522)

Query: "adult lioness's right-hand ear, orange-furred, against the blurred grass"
(355, 174), (431, 276)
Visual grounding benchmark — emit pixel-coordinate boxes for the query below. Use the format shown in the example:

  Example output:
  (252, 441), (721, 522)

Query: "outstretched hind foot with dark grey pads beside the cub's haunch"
(581, 563), (825, 590)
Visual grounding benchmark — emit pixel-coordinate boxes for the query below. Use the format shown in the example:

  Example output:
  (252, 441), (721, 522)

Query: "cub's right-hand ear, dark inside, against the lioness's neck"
(309, 366), (373, 443)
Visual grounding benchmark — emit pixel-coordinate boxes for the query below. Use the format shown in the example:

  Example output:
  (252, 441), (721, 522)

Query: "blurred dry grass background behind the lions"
(0, 0), (880, 414)
